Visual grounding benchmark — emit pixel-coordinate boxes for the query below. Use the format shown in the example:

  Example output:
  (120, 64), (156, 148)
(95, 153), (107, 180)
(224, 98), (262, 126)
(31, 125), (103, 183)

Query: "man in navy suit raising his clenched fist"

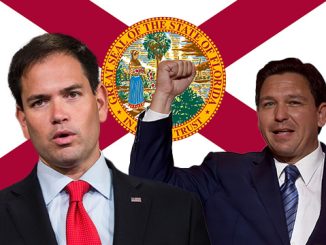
(129, 58), (326, 245)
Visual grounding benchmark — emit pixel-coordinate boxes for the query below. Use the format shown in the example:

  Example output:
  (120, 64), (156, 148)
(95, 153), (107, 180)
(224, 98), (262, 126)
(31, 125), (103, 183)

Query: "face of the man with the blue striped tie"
(257, 72), (326, 163)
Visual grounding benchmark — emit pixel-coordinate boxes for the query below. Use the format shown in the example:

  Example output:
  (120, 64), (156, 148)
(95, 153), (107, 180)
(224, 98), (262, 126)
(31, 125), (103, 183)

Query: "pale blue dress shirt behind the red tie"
(37, 153), (114, 245)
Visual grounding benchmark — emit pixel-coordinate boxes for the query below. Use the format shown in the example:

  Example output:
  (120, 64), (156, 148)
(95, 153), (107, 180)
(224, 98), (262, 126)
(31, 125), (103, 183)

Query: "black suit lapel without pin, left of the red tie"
(7, 167), (57, 245)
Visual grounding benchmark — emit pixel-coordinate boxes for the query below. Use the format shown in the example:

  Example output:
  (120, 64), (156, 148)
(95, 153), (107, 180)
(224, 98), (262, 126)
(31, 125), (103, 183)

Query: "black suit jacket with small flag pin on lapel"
(0, 158), (210, 245)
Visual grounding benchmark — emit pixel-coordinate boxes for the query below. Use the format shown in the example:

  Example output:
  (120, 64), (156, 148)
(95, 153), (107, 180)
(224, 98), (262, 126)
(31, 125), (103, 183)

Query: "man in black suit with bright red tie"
(0, 34), (209, 245)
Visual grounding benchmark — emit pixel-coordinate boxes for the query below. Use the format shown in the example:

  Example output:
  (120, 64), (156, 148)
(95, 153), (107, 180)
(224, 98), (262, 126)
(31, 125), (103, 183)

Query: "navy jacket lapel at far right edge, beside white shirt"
(307, 144), (326, 244)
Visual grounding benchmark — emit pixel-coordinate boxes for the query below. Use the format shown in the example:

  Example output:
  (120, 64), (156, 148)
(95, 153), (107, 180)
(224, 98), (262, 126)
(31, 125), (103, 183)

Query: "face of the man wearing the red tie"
(16, 53), (107, 172)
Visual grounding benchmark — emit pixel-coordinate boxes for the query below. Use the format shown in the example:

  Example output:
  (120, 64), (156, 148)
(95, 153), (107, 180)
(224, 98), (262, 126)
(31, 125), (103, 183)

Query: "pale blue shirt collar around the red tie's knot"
(37, 152), (113, 205)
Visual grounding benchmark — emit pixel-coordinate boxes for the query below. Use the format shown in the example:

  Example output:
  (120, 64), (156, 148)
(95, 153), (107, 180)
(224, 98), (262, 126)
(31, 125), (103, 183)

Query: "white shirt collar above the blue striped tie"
(274, 143), (324, 185)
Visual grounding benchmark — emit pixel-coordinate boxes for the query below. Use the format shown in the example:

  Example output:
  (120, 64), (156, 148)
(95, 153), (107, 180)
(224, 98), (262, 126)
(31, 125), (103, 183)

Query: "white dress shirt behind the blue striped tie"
(274, 144), (325, 245)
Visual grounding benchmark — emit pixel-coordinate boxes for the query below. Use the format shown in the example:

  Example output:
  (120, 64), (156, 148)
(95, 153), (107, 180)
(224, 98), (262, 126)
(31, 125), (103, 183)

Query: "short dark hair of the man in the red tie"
(8, 33), (99, 110)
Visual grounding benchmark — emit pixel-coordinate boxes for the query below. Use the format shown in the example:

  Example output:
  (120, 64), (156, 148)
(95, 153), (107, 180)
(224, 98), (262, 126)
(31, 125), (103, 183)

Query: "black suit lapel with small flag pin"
(107, 161), (151, 245)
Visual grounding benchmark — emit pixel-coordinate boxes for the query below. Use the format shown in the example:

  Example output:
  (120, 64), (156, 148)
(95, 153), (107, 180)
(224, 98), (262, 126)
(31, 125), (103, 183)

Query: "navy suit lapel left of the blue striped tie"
(253, 149), (290, 244)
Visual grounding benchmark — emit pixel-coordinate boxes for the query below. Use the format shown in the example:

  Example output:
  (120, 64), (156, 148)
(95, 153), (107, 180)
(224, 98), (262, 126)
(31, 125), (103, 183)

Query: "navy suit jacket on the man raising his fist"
(129, 114), (326, 245)
